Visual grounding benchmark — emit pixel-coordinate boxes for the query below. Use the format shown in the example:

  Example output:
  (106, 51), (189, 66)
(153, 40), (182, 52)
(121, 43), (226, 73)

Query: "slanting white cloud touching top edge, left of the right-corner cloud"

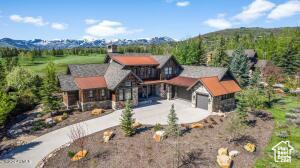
(234, 0), (275, 22)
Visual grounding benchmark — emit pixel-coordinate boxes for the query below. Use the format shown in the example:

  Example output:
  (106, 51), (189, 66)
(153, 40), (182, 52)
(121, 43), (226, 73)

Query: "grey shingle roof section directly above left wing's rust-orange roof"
(68, 64), (108, 77)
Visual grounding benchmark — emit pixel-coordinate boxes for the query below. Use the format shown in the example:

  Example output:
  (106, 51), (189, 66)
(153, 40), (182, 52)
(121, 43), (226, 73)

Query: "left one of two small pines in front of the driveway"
(121, 100), (134, 136)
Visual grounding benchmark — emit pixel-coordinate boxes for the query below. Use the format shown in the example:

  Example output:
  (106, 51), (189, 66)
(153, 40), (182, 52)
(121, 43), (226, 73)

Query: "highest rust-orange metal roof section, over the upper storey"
(111, 55), (159, 66)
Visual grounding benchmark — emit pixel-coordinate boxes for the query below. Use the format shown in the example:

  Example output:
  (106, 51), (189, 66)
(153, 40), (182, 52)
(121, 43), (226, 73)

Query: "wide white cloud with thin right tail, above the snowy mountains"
(85, 20), (143, 38)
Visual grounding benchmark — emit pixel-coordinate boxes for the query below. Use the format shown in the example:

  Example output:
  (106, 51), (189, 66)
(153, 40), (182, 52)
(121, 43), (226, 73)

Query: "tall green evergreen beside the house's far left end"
(41, 61), (59, 112)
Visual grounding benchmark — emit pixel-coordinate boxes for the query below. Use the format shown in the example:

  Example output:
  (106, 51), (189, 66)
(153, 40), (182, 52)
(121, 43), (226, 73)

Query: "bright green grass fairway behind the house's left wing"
(21, 54), (105, 75)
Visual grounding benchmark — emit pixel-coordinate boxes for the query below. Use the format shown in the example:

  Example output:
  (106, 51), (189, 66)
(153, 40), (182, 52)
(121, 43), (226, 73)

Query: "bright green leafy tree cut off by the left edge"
(0, 90), (15, 128)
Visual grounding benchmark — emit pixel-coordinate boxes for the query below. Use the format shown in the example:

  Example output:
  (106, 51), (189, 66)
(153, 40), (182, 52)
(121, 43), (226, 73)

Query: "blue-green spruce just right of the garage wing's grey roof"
(230, 47), (249, 87)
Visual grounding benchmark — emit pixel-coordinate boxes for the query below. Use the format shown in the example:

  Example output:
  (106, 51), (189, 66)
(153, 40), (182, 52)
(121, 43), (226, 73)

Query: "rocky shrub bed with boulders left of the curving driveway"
(0, 108), (113, 155)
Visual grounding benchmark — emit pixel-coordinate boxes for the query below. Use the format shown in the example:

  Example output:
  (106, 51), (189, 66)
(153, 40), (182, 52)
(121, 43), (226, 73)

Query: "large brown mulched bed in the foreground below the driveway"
(44, 111), (274, 168)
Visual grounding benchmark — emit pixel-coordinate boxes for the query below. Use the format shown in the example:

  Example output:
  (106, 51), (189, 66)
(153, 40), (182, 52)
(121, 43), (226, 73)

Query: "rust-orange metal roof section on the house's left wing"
(75, 76), (107, 89)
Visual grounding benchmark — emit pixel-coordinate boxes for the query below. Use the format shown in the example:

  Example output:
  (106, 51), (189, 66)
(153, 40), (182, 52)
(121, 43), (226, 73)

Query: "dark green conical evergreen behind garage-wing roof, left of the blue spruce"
(212, 36), (230, 67)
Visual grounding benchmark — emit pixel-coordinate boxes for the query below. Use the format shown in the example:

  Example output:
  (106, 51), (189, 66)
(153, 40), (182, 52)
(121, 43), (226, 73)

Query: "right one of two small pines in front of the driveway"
(167, 104), (180, 136)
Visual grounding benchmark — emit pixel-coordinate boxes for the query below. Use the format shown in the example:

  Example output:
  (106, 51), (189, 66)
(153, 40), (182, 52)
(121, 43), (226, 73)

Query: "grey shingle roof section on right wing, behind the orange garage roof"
(179, 65), (228, 79)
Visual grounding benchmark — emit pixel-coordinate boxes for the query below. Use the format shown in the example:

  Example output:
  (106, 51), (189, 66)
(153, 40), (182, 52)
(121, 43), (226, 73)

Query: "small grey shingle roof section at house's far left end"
(58, 75), (78, 91)
